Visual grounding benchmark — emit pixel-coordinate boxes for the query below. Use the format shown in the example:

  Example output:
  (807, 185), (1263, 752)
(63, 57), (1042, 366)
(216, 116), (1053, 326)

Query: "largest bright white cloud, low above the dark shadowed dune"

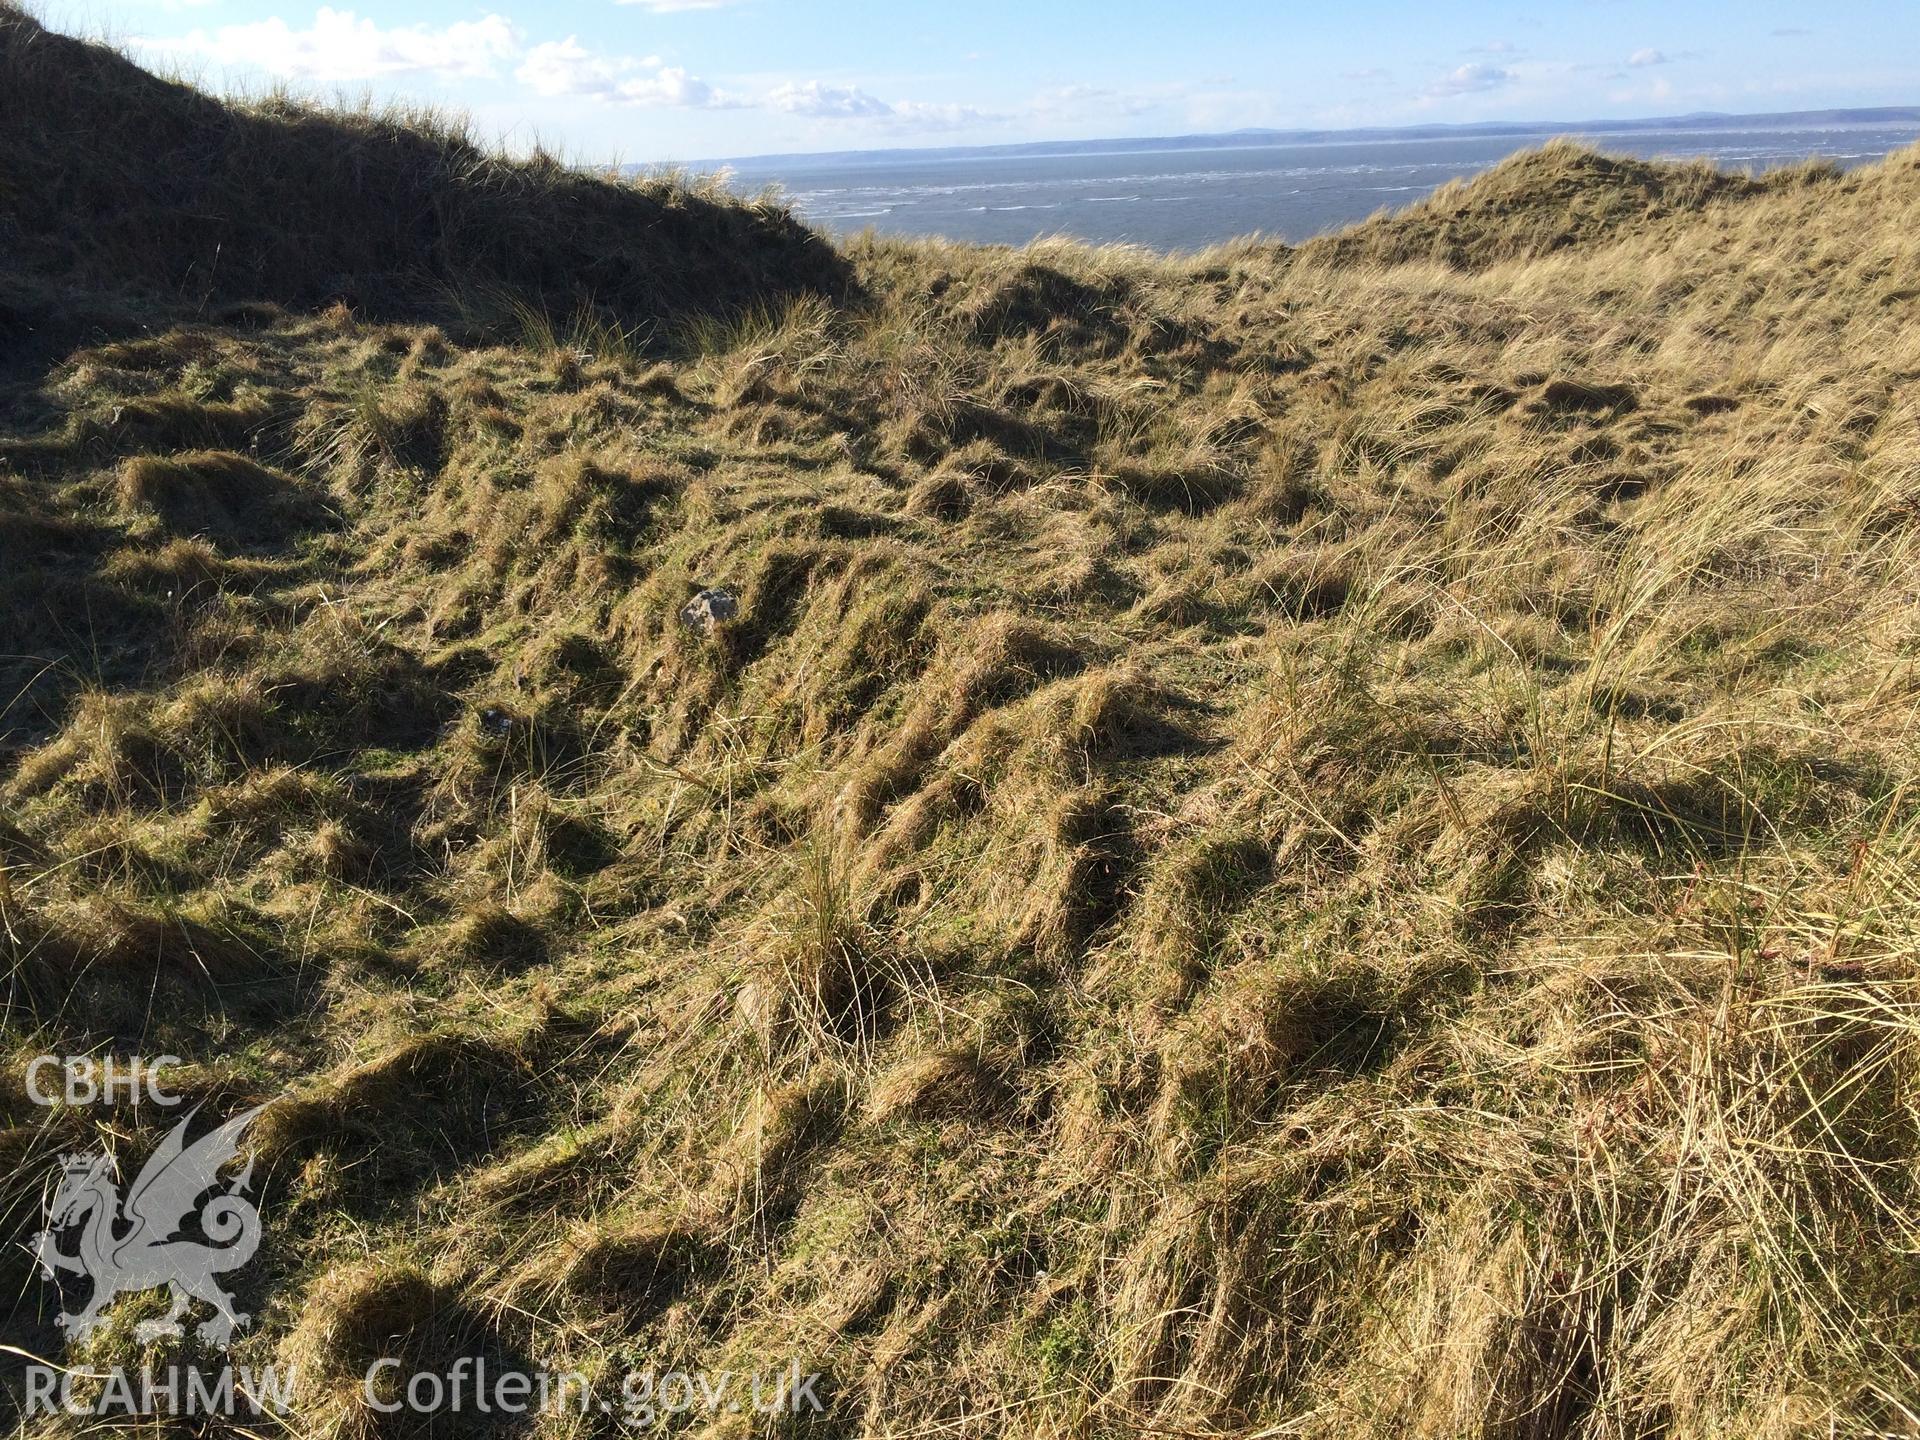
(142, 6), (520, 81)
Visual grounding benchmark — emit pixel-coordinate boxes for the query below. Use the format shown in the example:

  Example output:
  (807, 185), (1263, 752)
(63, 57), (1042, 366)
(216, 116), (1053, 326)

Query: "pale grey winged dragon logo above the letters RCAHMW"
(35, 1106), (265, 1348)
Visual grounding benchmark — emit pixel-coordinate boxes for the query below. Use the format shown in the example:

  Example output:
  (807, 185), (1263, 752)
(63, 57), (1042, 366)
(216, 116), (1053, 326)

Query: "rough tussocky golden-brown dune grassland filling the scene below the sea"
(0, 12), (1920, 1440)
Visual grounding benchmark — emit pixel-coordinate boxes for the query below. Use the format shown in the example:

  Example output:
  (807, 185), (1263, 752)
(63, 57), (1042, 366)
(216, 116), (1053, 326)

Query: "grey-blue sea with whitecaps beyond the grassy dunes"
(732, 125), (1920, 252)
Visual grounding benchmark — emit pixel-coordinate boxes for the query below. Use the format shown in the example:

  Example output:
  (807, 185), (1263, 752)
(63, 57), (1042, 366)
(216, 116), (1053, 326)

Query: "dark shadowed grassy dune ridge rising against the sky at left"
(0, 4), (845, 337)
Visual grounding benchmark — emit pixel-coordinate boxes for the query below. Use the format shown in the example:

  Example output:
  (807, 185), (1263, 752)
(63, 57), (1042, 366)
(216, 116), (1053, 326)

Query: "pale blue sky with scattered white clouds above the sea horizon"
(36, 0), (1920, 163)
